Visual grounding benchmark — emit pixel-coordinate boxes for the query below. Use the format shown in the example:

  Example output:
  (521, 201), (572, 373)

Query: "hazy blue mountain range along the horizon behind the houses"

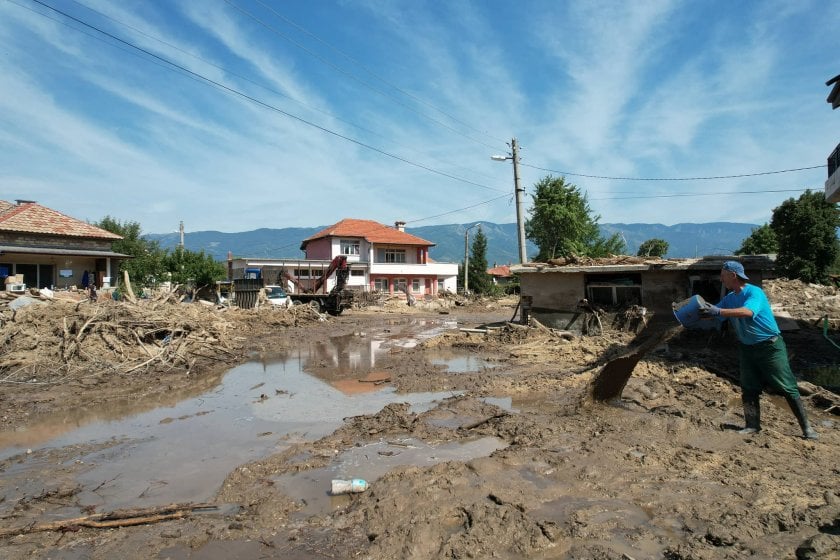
(144, 222), (758, 266)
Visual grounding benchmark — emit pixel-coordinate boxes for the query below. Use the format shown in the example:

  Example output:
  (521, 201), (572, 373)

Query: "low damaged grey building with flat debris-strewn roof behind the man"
(511, 255), (774, 328)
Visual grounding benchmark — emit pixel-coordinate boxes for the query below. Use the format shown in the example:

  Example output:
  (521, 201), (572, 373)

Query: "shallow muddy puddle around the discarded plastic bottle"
(275, 437), (507, 517)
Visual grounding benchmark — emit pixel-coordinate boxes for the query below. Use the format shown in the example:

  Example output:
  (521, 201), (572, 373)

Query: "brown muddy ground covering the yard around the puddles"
(0, 283), (840, 559)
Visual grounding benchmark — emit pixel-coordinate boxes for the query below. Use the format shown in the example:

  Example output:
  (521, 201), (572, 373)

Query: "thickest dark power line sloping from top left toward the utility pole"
(23, 0), (503, 195)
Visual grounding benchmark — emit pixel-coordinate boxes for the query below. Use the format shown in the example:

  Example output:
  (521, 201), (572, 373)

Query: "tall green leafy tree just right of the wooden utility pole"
(525, 175), (624, 261)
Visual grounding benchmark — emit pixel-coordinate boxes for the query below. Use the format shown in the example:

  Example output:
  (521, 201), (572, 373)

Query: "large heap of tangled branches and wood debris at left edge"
(0, 298), (241, 383)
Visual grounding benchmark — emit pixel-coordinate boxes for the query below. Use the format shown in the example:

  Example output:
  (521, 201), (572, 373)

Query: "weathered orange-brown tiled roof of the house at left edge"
(0, 200), (122, 239)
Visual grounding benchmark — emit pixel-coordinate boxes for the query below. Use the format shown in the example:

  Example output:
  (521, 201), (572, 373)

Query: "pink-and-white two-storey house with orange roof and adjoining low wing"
(229, 218), (458, 297)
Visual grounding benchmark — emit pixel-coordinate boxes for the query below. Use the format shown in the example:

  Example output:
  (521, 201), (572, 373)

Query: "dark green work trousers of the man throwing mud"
(740, 336), (799, 399)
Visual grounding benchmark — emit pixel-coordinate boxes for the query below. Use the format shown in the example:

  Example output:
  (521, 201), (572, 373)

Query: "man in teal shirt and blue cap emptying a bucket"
(701, 261), (819, 439)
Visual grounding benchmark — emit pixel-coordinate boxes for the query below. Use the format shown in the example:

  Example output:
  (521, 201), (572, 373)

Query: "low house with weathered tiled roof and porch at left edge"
(0, 200), (128, 291)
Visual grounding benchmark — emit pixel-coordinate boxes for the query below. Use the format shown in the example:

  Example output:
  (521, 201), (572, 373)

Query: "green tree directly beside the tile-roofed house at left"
(93, 216), (166, 286)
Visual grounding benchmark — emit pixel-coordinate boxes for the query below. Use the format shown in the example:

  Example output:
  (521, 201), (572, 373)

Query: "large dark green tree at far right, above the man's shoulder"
(770, 190), (840, 282)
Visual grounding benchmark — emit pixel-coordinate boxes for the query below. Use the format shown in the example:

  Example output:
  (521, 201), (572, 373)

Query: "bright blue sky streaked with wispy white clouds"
(0, 0), (840, 233)
